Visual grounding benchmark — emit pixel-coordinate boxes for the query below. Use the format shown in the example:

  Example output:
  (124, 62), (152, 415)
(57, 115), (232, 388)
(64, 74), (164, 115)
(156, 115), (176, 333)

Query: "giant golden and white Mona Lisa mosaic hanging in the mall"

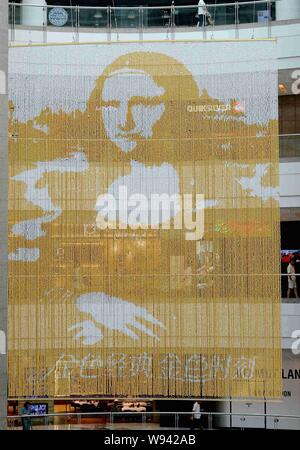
(9, 40), (281, 398)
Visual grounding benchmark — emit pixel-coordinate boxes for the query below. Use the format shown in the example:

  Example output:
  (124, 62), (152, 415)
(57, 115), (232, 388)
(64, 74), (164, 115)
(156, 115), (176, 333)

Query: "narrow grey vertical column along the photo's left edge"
(0, 1), (8, 429)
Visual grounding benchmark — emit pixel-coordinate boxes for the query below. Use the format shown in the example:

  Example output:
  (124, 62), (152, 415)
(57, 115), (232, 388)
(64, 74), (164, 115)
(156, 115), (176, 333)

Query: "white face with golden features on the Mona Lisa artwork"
(102, 69), (165, 153)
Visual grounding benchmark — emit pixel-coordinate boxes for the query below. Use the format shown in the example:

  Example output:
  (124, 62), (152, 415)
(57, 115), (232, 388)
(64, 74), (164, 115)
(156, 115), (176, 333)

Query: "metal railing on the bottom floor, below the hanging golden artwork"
(0, 411), (300, 430)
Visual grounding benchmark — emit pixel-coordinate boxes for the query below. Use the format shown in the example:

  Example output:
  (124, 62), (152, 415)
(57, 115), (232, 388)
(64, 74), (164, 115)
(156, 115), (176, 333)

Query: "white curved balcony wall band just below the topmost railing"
(9, 20), (300, 70)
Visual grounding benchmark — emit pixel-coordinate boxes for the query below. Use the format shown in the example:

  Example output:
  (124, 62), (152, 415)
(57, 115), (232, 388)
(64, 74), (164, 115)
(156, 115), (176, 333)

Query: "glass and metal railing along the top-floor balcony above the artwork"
(9, 0), (280, 42)
